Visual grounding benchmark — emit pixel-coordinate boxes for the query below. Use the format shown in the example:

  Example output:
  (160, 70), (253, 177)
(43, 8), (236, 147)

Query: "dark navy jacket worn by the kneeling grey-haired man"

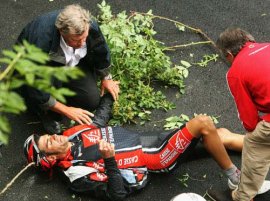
(17, 10), (110, 107)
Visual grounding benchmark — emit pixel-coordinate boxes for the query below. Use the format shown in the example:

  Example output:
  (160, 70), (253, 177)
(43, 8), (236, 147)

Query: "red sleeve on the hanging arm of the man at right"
(227, 75), (260, 131)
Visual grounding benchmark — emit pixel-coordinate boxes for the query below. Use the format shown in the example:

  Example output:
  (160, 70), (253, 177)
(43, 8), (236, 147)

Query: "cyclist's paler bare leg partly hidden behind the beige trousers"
(217, 128), (244, 152)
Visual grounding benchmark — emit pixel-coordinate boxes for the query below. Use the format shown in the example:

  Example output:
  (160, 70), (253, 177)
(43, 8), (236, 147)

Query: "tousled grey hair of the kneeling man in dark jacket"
(55, 4), (91, 35)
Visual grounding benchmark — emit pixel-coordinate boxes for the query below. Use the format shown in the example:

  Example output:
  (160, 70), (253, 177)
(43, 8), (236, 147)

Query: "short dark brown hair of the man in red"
(216, 28), (255, 56)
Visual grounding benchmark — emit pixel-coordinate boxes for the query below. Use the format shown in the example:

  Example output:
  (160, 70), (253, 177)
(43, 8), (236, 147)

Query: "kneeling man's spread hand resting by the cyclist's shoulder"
(65, 107), (94, 125)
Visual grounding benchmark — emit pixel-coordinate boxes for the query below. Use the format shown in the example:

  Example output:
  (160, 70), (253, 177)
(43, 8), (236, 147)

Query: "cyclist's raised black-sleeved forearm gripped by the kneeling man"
(92, 93), (114, 127)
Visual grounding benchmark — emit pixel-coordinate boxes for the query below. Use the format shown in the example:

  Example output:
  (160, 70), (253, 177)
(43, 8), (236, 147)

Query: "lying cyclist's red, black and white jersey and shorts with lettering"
(58, 125), (197, 198)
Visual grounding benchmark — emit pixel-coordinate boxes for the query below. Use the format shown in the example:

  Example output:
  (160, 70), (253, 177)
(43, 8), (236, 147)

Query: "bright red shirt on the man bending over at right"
(227, 42), (270, 131)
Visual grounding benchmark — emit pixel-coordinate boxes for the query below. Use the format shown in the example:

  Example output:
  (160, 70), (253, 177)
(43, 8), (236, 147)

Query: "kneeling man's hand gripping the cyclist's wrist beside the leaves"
(101, 80), (120, 101)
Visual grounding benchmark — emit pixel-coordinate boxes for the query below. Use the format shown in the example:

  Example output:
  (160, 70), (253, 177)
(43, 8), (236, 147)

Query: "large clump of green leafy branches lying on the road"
(98, 1), (188, 124)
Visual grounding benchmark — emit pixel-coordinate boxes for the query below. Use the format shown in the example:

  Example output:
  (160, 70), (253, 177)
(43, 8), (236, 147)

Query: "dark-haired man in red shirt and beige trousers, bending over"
(210, 28), (270, 201)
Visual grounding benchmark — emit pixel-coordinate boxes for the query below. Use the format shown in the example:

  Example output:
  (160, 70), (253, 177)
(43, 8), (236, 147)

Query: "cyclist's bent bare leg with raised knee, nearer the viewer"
(186, 115), (233, 170)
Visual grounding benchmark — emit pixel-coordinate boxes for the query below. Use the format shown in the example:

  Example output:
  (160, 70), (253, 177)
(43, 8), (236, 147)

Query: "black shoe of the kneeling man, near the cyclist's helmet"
(39, 113), (62, 134)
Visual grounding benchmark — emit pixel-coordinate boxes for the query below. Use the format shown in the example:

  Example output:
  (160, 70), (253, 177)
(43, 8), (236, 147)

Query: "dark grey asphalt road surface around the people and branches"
(0, 0), (270, 201)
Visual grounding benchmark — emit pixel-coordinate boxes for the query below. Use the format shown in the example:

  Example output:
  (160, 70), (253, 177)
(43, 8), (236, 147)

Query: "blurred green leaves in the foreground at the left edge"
(0, 41), (83, 144)
